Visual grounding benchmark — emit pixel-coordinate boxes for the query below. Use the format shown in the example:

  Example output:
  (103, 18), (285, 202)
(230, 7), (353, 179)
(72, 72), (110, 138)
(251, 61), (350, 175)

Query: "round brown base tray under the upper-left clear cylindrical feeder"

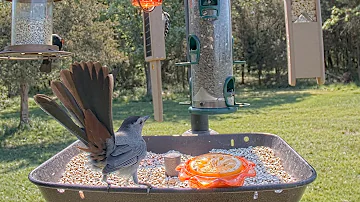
(0, 44), (71, 60)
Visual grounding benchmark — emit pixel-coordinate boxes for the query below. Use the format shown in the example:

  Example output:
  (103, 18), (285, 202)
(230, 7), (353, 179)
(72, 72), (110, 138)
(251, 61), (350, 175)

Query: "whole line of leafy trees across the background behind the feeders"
(0, 0), (360, 126)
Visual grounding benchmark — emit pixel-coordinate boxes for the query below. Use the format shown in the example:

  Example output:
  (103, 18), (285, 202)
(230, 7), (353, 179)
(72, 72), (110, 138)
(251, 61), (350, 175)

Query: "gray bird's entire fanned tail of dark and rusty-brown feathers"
(34, 62), (114, 161)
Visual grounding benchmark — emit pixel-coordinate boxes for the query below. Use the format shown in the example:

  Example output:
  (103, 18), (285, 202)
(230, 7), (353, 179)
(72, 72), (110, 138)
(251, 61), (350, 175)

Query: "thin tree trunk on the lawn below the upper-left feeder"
(20, 82), (30, 126)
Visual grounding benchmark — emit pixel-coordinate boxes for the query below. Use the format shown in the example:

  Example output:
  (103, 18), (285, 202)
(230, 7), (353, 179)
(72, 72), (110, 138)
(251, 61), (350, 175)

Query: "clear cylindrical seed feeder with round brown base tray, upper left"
(0, 0), (71, 60)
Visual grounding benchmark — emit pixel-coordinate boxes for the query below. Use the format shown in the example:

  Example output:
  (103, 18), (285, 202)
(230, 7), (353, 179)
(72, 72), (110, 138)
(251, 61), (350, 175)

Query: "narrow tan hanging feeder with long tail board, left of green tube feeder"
(143, 6), (166, 122)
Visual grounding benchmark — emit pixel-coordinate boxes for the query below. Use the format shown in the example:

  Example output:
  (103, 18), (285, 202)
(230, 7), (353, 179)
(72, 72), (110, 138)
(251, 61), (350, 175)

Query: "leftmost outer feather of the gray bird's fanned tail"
(34, 94), (89, 146)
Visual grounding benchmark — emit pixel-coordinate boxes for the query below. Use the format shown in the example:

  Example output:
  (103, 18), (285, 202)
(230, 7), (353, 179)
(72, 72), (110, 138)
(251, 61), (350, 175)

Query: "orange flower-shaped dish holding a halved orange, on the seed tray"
(176, 153), (256, 189)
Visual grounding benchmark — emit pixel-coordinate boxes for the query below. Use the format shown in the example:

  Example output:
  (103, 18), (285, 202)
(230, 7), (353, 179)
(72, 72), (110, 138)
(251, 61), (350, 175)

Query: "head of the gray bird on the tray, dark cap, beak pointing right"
(118, 116), (150, 137)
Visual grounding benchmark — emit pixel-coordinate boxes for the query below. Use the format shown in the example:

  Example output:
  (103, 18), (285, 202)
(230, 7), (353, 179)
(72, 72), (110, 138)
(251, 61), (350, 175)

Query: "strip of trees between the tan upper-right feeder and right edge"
(322, 0), (360, 81)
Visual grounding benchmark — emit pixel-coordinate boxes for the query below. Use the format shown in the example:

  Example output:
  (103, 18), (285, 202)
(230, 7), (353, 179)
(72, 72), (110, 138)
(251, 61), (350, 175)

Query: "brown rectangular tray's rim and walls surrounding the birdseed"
(29, 133), (316, 202)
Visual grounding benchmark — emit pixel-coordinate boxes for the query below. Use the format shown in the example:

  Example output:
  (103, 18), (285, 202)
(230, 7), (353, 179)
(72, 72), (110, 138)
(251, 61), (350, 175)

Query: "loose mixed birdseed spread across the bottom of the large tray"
(60, 146), (296, 188)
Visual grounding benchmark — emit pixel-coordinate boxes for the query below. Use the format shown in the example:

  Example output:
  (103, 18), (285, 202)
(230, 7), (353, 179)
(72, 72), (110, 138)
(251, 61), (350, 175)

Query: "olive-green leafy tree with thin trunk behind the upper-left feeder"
(0, 0), (126, 125)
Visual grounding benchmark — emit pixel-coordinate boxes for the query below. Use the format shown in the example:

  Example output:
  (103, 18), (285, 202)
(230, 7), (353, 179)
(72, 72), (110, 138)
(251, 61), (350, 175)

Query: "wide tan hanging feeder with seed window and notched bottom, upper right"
(284, 0), (325, 86)
